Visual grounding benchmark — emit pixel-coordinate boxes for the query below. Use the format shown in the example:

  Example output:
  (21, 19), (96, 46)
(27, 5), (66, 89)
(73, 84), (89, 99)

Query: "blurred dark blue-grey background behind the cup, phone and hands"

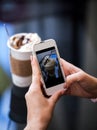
(0, 0), (97, 130)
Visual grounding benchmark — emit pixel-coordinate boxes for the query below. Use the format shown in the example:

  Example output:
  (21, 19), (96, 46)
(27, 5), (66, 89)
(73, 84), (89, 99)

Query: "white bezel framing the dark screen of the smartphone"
(33, 39), (65, 95)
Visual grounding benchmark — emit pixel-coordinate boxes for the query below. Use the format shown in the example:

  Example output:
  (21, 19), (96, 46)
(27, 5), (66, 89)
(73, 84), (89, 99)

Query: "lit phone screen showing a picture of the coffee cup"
(36, 47), (64, 88)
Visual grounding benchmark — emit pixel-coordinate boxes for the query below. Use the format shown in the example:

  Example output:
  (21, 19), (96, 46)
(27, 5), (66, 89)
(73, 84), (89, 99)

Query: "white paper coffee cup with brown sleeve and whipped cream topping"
(7, 33), (41, 87)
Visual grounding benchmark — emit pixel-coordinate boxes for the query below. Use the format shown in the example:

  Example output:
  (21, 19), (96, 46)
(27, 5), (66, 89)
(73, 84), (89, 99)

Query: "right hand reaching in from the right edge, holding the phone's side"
(61, 59), (97, 98)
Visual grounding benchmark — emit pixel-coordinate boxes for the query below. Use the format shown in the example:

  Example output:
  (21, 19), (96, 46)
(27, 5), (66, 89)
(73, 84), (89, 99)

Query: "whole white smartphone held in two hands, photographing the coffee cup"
(33, 39), (65, 95)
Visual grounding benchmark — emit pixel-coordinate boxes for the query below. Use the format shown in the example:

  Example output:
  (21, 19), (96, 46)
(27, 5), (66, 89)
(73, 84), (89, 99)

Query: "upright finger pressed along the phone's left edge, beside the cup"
(31, 56), (41, 86)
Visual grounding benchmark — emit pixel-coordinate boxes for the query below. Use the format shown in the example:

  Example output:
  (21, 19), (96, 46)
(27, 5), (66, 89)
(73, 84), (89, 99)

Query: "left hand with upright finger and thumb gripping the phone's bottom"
(24, 56), (65, 130)
